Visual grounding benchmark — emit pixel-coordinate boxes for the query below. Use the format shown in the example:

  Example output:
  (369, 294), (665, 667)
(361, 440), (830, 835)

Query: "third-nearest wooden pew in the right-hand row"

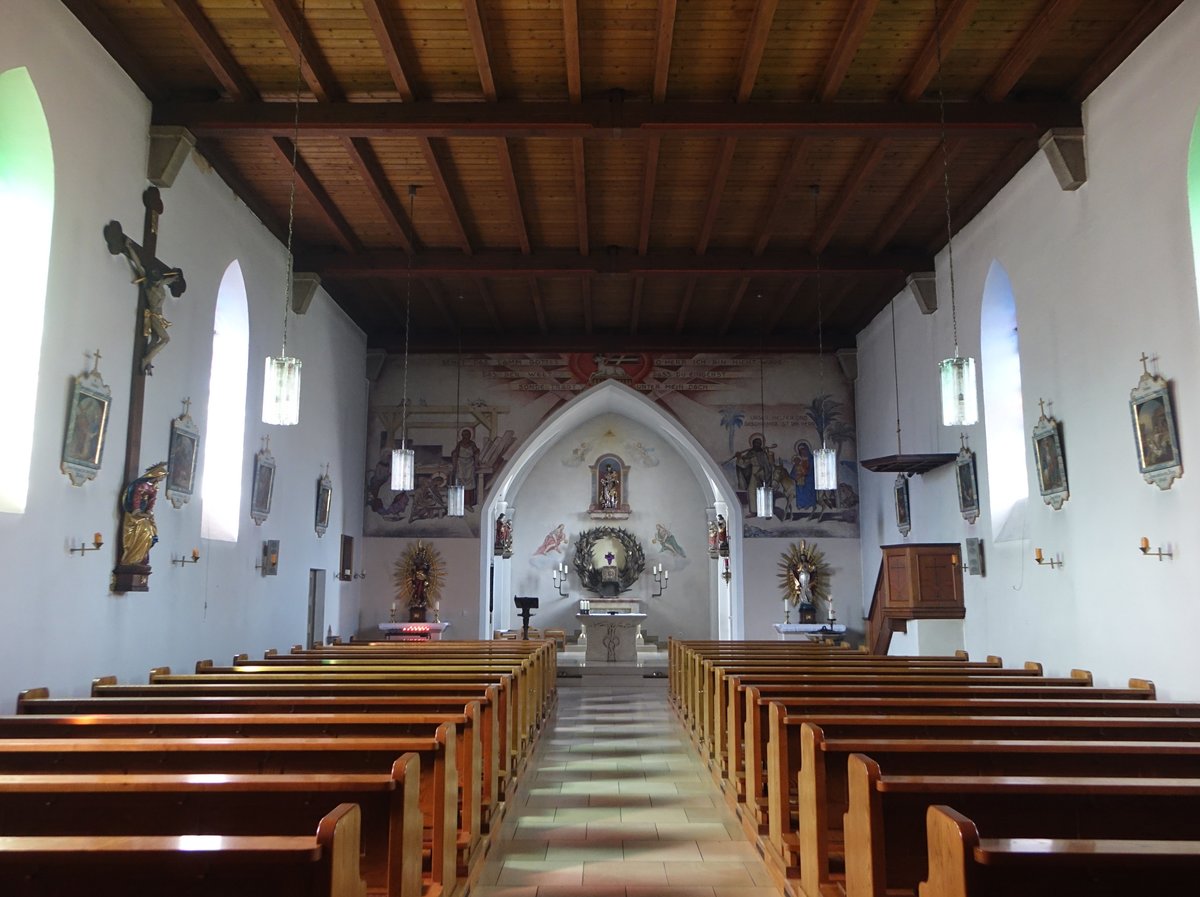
(787, 723), (1200, 893)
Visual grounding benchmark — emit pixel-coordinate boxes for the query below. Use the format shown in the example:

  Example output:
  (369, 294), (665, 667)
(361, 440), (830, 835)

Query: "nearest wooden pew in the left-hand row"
(0, 803), (366, 897)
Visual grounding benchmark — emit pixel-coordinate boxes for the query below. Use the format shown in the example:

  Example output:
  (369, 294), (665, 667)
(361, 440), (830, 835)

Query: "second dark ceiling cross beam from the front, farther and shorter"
(307, 249), (932, 279)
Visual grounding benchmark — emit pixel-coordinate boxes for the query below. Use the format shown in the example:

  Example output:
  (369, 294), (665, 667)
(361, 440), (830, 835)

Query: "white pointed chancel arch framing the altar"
(479, 380), (745, 639)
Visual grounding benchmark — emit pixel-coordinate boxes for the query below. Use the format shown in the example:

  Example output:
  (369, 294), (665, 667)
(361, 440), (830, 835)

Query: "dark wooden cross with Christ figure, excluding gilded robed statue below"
(106, 187), (187, 594)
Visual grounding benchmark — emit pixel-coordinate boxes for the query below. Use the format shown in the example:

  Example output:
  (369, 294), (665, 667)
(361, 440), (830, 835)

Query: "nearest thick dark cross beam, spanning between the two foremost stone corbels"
(154, 101), (1082, 140)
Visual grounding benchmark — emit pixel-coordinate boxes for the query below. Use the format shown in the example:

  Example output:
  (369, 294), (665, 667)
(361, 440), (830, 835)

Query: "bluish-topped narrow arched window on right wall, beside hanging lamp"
(979, 261), (1030, 542)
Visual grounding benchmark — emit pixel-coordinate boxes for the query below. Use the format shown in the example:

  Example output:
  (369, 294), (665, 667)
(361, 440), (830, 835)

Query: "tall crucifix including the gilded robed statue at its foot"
(104, 187), (187, 594)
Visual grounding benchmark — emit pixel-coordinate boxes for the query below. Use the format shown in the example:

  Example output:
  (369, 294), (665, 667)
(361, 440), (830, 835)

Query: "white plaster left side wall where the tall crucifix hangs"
(0, 0), (366, 709)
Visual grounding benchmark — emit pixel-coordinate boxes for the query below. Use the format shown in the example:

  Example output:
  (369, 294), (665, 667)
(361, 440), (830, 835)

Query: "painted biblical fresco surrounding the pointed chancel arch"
(364, 353), (858, 537)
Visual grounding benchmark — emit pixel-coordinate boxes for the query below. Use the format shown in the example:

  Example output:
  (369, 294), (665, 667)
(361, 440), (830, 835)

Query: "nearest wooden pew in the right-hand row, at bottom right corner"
(919, 806), (1200, 897)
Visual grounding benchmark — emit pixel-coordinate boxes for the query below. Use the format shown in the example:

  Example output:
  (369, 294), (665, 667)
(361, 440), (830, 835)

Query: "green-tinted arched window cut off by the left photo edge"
(0, 68), (54, 513)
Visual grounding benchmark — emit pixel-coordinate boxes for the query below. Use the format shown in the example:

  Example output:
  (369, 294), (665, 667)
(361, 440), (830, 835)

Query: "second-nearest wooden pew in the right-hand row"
(844, 754), (1200, 897)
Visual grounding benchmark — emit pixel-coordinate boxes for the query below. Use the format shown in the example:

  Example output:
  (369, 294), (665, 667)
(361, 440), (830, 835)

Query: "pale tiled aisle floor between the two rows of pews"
(472, 679), (781, 897)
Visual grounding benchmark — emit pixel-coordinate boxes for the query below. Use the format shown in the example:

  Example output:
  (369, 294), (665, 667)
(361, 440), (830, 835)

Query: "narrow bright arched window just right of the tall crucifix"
(200, 261), (250, 542)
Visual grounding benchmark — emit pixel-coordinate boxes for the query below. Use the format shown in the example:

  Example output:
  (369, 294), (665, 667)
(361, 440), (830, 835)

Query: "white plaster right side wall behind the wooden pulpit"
(857, 0), (1200, 698)
